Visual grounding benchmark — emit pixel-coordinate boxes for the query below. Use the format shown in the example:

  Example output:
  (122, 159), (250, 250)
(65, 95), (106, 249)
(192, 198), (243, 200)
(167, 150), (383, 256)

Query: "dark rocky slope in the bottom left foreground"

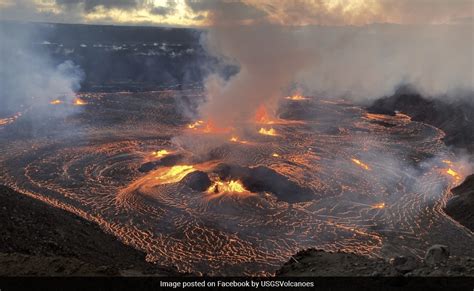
(0, 186), (178, 276)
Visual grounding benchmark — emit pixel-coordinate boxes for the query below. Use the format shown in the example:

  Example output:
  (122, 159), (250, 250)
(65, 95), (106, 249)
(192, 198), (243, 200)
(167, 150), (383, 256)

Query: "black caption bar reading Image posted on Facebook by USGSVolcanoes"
(0, 277), (474, 291)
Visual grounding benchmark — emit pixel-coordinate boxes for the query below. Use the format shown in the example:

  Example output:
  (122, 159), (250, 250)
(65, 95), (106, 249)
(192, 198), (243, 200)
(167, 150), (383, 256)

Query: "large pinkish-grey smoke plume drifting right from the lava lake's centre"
(195, 1), (474, 126)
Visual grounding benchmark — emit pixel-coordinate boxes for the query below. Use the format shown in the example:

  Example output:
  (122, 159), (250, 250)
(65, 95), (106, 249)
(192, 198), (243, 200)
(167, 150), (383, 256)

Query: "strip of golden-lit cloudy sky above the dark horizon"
(0, 0), (474, 26)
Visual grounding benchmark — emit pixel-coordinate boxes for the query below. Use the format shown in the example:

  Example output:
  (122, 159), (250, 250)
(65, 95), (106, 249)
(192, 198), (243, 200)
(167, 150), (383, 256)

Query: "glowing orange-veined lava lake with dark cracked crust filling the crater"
(0, 88), (474, 275)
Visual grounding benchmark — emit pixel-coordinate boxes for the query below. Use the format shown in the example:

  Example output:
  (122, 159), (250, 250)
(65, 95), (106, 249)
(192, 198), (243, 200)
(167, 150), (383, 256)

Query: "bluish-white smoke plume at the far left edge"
(0, 23), (84, 115)
